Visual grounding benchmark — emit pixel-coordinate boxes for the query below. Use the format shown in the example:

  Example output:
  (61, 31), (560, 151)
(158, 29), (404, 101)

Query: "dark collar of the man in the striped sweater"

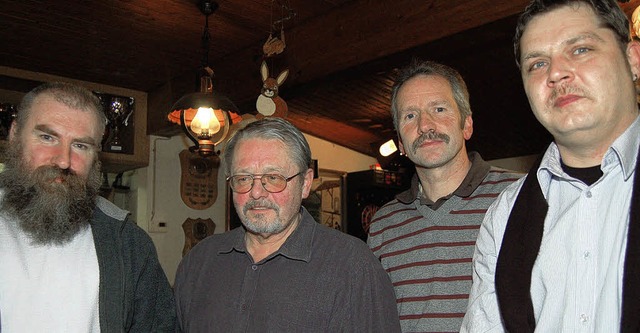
(396, 151), (491, 204)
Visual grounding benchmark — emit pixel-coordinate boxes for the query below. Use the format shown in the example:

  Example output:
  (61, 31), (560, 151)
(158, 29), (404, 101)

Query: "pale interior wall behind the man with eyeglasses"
(134, 131), (376, 284)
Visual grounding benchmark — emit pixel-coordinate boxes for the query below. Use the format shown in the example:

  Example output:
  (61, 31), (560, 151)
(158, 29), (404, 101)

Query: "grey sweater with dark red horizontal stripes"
(367, 152), (523, 332)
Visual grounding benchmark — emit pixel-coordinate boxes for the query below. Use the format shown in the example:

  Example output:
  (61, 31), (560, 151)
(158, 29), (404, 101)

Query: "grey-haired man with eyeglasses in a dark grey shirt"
(175, 118), (400, 332)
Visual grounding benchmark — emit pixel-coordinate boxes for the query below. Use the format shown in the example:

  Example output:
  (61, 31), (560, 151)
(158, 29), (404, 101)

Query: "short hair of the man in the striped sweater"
(391, 59), (471, 131)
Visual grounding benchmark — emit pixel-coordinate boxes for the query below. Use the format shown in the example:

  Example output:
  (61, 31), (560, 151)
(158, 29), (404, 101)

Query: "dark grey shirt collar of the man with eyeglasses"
(219, 207), (318, 262)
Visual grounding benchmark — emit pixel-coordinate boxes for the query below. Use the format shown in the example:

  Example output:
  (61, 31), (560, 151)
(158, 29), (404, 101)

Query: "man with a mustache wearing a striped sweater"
(367, 60), (522, 332)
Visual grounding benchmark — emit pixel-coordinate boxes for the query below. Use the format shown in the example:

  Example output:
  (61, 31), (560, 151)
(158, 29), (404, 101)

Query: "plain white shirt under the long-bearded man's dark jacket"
(0, 210), (100, 333)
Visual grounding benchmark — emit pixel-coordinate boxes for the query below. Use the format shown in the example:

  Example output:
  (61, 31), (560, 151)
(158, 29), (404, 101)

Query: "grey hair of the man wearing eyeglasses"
(223, 117), (311, 176)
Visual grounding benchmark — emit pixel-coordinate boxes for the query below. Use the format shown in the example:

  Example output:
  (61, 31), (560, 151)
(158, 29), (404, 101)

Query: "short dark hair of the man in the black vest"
(513, 0), (631, 68)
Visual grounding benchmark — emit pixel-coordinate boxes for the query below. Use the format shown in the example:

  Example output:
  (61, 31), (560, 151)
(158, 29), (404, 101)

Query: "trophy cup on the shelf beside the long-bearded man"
(100, 95), (134, 153)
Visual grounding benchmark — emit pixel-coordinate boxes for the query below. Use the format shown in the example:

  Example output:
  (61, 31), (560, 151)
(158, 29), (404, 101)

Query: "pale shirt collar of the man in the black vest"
(537, 117), (640, 187)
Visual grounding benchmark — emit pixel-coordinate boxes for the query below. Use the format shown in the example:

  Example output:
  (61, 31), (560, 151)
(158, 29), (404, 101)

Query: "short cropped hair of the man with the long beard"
(15, 82), (107, 133)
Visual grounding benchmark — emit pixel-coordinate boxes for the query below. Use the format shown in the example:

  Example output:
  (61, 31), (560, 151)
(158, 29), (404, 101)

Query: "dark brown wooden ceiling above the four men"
(0, 0), (640, 159)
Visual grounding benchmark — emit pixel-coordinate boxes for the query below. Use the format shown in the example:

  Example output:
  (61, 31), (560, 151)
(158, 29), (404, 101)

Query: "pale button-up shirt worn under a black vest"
(462, 118), (640, 332)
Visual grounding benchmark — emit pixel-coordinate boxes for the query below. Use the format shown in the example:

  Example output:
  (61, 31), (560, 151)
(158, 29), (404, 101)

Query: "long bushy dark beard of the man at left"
(0, 144), (100, 245)
